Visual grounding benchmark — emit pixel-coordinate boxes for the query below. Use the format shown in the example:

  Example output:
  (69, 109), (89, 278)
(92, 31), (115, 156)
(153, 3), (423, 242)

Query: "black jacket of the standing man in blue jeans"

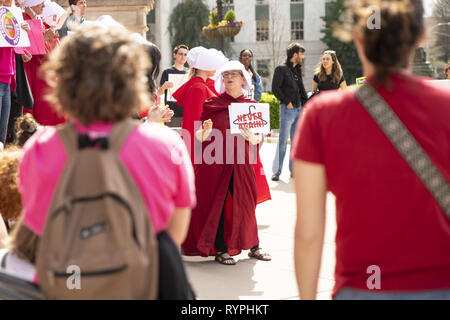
(272, 60), (308, 108)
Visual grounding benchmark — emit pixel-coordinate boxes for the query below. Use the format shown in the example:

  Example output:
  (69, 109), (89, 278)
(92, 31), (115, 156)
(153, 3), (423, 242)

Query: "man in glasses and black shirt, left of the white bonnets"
(158, 44), (189, 127)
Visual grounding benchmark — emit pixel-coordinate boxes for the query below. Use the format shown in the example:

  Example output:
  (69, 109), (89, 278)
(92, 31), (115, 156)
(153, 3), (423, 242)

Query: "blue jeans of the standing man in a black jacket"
(272, 104), (302, 175)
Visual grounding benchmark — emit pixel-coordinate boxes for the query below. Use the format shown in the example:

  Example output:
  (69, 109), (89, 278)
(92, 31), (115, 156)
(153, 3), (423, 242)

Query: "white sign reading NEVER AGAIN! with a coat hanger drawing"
(228, 103), (270, 134)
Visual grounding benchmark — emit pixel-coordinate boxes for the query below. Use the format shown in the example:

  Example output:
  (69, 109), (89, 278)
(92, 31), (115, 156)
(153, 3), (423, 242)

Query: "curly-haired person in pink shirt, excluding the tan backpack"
(9, 26), (196, 298)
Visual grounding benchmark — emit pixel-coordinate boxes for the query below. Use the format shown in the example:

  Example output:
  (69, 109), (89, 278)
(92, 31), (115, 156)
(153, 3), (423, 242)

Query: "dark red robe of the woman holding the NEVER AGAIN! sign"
(182, 93), (270, 256)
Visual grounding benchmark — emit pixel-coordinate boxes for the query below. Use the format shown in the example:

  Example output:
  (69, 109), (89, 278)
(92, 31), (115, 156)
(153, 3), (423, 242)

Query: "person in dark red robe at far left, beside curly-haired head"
(20, 0), (66, 126)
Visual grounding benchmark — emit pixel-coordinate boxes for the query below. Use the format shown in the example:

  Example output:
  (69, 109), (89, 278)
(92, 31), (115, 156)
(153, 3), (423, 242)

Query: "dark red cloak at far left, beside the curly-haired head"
(23, 13), (66, 126)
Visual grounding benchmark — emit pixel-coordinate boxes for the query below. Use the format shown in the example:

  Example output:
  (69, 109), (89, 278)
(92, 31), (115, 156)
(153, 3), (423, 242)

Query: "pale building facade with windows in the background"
(147, 0), (336, 91)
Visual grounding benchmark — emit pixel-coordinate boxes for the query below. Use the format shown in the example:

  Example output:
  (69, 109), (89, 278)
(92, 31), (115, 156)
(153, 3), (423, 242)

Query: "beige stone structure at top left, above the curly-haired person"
(55, 0), (155, 38)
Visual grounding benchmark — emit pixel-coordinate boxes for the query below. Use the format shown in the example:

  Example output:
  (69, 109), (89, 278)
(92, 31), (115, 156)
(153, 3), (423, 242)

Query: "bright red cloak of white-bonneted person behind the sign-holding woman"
(173, 77), (215, 163)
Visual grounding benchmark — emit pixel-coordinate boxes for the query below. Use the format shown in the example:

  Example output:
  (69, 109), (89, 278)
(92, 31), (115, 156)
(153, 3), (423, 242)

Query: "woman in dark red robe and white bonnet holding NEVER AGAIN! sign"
(182, 61), (271, 265)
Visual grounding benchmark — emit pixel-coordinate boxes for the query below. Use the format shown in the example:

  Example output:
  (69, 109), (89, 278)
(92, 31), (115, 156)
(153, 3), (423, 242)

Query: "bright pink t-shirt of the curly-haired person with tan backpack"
(19, 123), (196, 235)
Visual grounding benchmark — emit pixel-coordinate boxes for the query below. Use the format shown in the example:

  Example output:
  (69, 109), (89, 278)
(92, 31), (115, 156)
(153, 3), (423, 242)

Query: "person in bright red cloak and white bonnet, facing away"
(173, 47), (228, 163)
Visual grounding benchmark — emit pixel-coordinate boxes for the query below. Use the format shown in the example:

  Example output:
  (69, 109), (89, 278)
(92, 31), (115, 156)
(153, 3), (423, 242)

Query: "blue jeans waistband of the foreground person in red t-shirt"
(334, 288), (450, 300)
